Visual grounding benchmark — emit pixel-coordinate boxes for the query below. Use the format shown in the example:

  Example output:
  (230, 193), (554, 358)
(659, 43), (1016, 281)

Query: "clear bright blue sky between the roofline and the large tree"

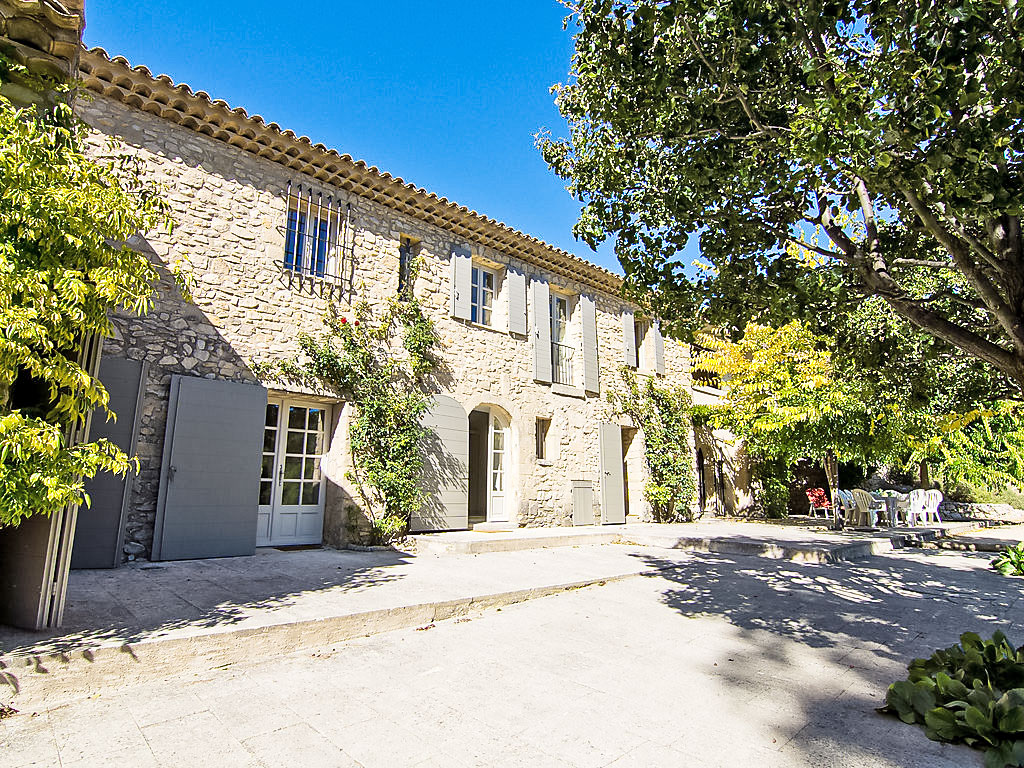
(79, 0), (621, 272)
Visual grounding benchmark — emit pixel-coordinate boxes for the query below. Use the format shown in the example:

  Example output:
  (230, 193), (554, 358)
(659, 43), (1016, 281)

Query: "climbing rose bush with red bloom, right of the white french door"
(257, 290), (439, 543)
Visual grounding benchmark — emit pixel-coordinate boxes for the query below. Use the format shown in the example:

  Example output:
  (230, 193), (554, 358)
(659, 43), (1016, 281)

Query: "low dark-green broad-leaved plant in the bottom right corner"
(882, 632), (1024, 768)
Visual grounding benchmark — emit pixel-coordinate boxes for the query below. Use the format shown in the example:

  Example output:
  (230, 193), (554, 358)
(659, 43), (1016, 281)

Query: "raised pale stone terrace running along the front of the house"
(0, 522), (1010, 703)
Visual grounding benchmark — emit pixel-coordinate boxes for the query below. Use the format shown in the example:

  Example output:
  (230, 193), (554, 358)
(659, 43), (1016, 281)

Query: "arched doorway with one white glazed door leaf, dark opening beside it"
(469, 406), (512, 526)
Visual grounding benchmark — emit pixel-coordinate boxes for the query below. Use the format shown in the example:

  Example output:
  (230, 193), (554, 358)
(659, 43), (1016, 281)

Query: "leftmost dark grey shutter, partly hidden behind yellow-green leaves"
(71, 355), (147, 568)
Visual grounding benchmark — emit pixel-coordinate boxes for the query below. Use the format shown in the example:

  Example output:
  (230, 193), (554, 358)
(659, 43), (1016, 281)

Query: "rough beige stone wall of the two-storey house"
(78, 96), (689, 553)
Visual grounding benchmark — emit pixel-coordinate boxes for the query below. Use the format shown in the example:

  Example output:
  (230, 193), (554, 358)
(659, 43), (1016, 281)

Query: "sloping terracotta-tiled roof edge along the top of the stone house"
(80, 48), (622, 294)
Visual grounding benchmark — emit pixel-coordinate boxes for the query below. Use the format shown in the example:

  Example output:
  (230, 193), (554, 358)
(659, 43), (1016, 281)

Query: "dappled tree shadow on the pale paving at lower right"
(637, 551), (1024, 768)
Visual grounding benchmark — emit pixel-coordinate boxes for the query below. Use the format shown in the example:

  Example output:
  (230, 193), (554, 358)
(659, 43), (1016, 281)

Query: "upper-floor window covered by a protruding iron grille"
(284, 184), (348, 282)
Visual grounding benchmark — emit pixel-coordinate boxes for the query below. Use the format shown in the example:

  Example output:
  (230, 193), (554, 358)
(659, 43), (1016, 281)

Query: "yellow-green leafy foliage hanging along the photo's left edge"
(0, 59), (168, 526)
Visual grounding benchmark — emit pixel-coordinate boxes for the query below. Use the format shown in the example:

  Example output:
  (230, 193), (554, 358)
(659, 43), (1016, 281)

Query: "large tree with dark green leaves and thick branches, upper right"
(539, 0), (1024, 387)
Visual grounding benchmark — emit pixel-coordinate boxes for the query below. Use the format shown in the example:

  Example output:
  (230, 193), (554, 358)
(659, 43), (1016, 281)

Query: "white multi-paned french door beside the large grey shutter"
(256, 396), (330, 547)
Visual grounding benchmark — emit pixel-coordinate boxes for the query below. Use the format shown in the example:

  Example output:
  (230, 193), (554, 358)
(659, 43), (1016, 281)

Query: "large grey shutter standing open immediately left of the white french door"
(153, 376), (266, 560)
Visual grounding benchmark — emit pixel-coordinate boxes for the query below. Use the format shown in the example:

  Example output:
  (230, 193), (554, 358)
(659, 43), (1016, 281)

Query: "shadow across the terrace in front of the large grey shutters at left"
(0, 549), (412, 655)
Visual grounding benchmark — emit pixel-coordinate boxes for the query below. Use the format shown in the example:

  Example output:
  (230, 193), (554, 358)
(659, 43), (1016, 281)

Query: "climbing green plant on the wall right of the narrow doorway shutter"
(608, 368), (696, 522)
